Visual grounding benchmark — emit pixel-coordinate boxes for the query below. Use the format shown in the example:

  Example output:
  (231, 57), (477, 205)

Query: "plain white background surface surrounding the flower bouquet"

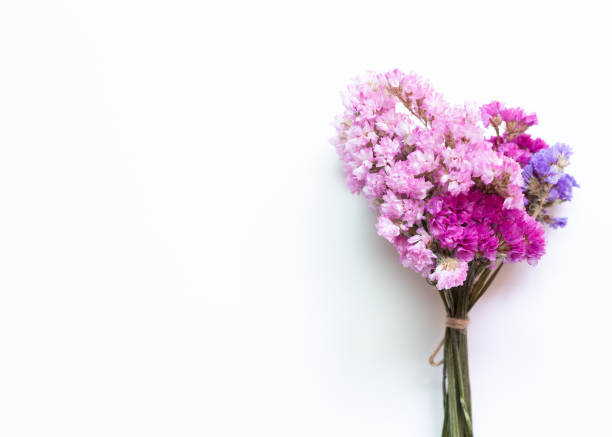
(0, 0), (612, 437)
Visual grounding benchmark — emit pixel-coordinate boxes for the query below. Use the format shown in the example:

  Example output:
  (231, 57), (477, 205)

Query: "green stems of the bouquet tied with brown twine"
(439, 261), (503, 437)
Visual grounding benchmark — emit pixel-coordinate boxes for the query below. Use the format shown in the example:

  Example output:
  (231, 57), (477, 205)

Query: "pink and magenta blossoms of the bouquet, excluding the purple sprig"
(332, 70), (544, 289)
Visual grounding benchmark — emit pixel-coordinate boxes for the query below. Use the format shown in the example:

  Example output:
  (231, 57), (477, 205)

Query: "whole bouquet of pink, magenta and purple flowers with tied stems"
(332, 70), (578, 437)
